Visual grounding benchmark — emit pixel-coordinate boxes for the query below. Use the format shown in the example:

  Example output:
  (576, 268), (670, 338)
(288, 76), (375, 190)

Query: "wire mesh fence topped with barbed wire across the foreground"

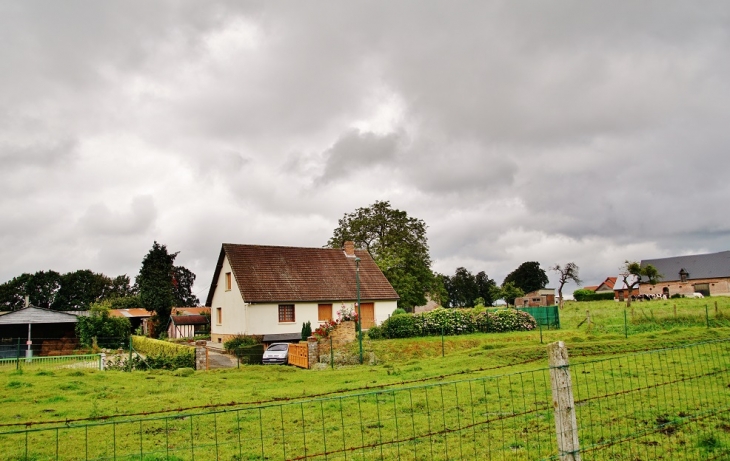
(0, 340), (730, 461)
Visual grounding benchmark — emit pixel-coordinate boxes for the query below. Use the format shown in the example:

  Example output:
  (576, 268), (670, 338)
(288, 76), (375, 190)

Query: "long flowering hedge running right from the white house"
(368, 308), (537, 339)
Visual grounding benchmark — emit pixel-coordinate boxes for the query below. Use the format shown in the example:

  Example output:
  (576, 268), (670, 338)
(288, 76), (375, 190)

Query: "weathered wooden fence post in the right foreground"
(547, 341), (581, 461)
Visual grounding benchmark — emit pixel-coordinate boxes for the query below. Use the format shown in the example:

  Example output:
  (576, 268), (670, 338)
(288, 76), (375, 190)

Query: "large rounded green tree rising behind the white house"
(327, 201), (434, 310)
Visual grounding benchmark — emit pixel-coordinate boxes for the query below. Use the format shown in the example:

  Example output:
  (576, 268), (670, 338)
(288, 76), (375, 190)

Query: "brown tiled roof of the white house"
(206, 243), (399, 306)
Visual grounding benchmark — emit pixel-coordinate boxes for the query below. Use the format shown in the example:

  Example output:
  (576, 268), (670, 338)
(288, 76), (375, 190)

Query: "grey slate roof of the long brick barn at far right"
(641, 251), (730, 281)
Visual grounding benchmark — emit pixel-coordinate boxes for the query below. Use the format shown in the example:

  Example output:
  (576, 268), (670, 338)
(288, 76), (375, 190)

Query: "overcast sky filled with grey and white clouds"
(0, 0), (730, 299)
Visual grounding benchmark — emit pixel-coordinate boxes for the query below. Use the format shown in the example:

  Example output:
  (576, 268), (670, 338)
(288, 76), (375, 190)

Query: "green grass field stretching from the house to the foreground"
(0, 298), (730, 460)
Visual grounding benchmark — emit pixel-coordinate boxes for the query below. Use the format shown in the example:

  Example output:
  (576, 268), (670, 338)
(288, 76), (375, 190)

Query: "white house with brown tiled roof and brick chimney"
(205, 242), (399, 342)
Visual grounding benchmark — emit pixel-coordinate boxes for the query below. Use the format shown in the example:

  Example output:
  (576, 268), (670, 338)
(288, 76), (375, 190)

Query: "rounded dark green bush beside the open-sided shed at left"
(76, 301), (132, 348)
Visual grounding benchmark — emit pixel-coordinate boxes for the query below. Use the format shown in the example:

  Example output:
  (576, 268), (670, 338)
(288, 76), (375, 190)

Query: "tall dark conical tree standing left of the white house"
(136, 241), (199, 335)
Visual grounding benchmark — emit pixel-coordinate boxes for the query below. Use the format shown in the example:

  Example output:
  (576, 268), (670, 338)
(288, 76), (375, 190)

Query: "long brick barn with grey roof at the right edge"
(640, 251), (730, 297)
